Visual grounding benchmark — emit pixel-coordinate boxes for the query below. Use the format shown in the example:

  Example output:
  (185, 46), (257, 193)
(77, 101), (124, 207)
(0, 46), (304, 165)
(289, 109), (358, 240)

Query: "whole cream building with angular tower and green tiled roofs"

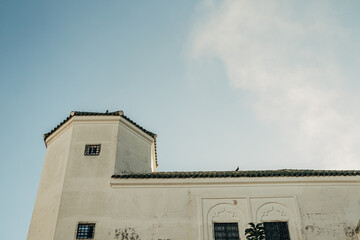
(28, 111), (360, 240)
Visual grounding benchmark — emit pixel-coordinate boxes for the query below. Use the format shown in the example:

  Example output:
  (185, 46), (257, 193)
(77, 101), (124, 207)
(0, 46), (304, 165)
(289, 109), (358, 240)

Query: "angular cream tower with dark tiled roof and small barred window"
(28, 111), (157, 240)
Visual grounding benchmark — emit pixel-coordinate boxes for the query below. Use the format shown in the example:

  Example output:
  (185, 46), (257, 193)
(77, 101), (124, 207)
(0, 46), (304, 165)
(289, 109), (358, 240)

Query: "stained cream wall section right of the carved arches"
(299, 185), (360, 240)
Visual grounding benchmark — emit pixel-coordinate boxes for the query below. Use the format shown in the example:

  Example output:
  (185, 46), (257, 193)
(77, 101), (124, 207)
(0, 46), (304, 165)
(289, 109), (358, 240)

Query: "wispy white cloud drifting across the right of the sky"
(192, 1), (360, 169)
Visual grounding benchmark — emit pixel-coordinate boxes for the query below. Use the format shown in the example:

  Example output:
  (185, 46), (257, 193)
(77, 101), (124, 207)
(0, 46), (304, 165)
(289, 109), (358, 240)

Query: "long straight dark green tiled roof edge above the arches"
(112, 169), (360, 179)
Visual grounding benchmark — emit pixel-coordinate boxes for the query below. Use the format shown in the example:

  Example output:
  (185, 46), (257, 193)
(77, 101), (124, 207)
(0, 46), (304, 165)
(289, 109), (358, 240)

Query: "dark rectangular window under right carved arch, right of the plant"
(264, 222), (290, 240)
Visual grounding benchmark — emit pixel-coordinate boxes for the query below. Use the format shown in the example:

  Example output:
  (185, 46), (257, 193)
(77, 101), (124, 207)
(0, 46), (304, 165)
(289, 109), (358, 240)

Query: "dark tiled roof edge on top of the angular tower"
(43, 111), (158, 166)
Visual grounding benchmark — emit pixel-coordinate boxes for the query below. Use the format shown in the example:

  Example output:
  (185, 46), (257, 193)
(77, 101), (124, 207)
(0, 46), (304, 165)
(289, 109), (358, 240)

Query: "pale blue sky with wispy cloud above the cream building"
(0, 0), (360, 239)
